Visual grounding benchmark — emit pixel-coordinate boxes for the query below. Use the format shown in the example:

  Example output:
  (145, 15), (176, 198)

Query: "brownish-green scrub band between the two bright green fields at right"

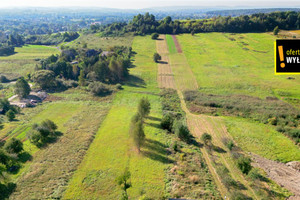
(184, 91), (300, 143)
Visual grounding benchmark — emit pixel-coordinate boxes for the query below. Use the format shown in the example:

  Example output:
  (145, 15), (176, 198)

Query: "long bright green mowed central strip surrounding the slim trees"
(63, 36), (170, 199)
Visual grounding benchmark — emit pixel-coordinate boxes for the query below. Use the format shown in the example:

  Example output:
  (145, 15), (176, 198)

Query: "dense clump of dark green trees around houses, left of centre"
(32, 46), (132, 95)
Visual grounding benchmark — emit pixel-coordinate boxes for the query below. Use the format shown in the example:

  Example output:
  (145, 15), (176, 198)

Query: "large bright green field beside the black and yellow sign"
(177, 33), (300, 98)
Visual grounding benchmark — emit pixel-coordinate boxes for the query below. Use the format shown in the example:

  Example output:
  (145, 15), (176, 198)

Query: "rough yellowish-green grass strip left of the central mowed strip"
(10, 91), (111, 199)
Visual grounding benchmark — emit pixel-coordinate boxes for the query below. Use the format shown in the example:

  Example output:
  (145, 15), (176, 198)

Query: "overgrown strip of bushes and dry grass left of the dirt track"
(161, 89), (220, 199)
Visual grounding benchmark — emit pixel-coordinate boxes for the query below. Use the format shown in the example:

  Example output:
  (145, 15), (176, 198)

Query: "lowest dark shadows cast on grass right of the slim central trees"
(141, 139), (174, 164)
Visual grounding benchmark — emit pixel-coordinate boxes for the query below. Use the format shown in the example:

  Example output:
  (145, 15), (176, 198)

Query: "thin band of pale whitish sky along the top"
(0, 0), (300, 9)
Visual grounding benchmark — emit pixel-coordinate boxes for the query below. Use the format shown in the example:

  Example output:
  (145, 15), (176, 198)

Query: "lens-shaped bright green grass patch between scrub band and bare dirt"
(224, 117), (300, 163)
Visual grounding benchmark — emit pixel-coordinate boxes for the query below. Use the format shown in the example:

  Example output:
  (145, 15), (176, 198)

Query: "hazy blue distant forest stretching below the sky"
(0, 7), (300, 36)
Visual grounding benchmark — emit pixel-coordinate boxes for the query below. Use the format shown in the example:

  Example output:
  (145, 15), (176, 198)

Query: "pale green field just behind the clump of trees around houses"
(66, 34), (133, 50)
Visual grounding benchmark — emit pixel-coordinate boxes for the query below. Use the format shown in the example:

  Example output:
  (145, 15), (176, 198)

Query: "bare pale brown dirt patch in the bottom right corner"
(251, 154), (300, 200)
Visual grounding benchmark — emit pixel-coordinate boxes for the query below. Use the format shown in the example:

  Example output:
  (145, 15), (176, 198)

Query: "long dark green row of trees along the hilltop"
(93, 11), (300, 35)
